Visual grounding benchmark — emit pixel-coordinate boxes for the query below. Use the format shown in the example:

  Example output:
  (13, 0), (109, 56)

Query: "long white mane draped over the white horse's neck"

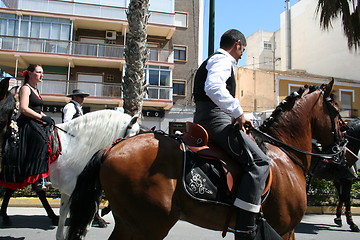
(56, 110), (137, 175)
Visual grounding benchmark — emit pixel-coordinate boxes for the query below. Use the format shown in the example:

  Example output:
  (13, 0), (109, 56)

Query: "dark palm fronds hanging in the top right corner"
(316, 0), (360, 50)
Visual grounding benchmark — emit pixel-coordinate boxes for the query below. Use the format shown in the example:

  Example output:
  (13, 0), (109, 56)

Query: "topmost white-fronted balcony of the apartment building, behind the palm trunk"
(2, 0), (184, 39)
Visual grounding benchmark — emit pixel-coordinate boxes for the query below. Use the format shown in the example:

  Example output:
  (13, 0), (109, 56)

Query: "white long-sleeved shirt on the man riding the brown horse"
(204, 48), (243, 119)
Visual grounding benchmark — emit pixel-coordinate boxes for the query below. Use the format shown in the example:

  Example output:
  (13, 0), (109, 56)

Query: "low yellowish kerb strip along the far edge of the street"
(0, 197), (360, 216)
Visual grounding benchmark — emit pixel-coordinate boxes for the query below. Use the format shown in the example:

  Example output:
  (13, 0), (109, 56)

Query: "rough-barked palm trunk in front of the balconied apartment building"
(123, 0), (149, 116)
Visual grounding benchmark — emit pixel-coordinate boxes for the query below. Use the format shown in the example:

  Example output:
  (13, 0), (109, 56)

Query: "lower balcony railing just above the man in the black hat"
(38, 79), (172, 100)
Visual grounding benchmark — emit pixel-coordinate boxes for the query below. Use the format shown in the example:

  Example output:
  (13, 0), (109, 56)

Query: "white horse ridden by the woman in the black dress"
(50, 110), (140, 240)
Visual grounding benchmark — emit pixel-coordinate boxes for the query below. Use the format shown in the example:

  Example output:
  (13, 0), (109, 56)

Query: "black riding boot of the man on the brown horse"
(235, 208), (258, 240)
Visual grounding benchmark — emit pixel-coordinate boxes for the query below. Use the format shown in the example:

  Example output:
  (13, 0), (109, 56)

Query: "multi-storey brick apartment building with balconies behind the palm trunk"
(0, 0), (203, 131)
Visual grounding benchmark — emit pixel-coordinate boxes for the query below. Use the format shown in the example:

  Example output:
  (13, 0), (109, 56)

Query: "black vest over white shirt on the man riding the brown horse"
(193, 52), (236, 102)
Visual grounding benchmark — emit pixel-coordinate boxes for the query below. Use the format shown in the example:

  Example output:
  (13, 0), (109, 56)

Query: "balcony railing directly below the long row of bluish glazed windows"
(0, 35), (174, 63)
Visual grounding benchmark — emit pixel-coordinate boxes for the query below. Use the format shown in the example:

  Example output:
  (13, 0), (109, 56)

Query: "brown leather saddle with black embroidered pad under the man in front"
(181, 122), (272, 205)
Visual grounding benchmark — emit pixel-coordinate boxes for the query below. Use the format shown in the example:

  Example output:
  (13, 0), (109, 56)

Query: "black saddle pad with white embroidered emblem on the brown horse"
(183, 150), (234, 205)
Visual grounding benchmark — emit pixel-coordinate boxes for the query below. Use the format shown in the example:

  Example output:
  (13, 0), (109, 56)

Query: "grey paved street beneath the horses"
(0, 207), (360, 240)
